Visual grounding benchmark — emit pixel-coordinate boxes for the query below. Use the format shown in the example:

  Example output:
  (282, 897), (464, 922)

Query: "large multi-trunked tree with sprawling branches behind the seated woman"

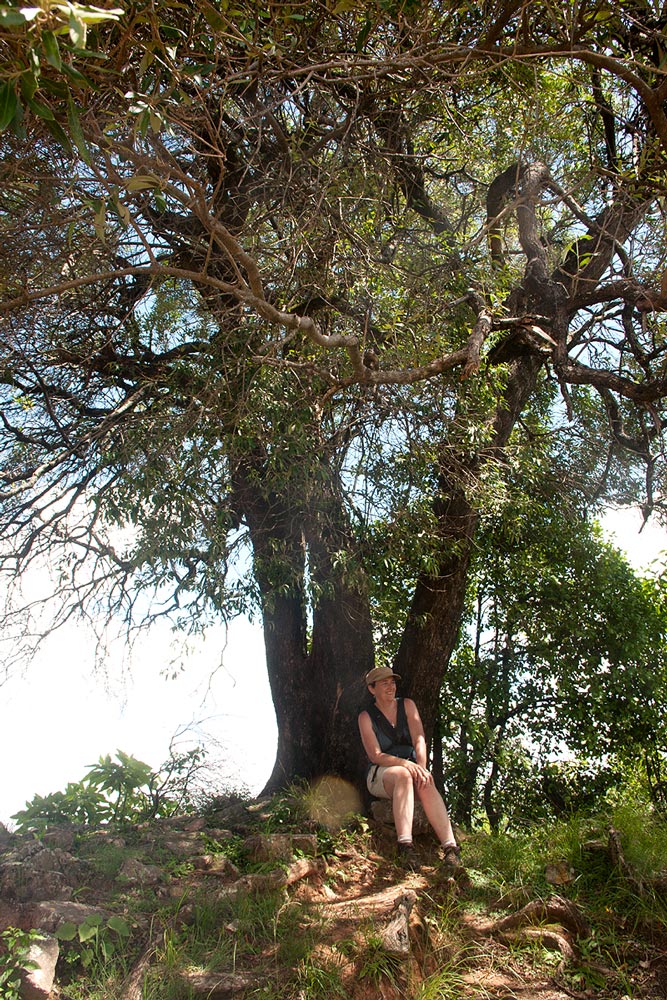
(0, 0), (667, 786)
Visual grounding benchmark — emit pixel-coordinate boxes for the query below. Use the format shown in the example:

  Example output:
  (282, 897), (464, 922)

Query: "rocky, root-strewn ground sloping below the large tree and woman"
(0, 802), (667, 1000)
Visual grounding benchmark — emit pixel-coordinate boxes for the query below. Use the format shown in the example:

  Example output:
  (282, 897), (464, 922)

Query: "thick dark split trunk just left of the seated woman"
(235, 458), (373, 791)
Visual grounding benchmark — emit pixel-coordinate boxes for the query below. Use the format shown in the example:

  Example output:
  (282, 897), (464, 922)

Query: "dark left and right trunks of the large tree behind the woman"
(235, 355), (540, 791)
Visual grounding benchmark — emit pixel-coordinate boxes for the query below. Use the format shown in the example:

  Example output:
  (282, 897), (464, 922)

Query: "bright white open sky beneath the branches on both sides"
(0, 511), (667, 825)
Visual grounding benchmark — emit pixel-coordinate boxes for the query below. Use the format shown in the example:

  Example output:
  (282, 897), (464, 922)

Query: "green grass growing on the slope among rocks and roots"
(47, 793), (667, 1000)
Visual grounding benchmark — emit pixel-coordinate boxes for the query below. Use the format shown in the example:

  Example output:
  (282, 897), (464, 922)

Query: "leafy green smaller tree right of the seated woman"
(442, 498), (667, 829)
